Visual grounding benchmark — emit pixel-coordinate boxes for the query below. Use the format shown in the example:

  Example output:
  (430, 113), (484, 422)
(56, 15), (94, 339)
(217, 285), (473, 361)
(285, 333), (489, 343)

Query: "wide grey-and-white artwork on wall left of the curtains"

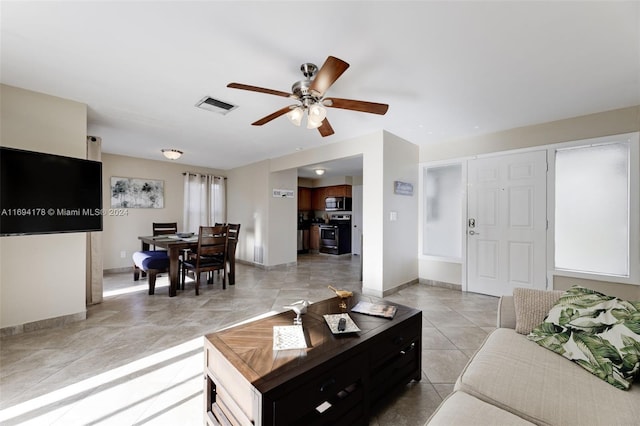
(111, 176), (164, 209)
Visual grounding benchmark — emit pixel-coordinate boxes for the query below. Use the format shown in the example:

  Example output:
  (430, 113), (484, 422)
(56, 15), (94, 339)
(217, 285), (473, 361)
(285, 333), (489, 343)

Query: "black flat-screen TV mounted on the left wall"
(0, 147), (102, 236)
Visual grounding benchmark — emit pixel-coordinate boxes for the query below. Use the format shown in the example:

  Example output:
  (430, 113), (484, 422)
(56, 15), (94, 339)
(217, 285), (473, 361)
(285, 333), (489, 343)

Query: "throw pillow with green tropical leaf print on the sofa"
(527, 286), (640, 390)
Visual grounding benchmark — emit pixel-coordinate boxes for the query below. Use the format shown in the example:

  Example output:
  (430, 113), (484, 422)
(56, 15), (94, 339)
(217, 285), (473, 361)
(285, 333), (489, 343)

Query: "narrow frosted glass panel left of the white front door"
(423, 164), (462, 259)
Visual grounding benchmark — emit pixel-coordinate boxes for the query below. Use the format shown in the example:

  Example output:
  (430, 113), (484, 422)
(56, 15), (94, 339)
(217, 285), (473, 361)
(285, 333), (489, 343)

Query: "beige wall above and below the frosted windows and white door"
(419, 106), (640, 300)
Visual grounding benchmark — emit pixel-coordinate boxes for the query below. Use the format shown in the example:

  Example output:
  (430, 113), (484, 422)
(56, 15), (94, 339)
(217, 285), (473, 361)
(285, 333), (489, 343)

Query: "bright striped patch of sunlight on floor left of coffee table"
(0, 337), (203, 425)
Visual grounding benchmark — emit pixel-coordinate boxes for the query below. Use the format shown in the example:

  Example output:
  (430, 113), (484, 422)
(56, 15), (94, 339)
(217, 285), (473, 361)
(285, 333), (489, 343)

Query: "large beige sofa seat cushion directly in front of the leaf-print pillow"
(455, 328), (640, 426)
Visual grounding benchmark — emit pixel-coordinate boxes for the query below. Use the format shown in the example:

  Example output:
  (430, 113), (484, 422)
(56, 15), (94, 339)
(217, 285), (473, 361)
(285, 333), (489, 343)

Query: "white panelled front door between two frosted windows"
(467, 151), (547, 296)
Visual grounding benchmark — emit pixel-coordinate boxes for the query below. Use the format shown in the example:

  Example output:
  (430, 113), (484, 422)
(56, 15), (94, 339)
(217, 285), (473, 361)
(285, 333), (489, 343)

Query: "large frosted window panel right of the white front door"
(555, 143), (630, 276)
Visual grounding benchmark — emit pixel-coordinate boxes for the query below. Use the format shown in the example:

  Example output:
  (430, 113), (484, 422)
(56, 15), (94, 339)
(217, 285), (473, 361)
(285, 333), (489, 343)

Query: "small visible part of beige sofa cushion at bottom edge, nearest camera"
(426, 392), (533, 426)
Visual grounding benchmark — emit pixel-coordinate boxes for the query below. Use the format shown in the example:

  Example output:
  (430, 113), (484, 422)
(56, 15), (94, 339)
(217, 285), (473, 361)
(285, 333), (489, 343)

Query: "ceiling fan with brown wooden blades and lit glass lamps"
(227, 56), (389, 137)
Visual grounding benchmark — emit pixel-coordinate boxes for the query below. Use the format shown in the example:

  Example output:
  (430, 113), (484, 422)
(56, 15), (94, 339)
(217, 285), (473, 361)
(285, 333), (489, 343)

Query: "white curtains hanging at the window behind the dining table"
(183, 173), (227, 233)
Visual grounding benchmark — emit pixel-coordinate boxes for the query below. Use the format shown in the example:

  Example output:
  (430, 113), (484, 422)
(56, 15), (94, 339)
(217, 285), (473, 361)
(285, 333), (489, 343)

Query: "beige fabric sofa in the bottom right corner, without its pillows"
(427, 296), (640, 426)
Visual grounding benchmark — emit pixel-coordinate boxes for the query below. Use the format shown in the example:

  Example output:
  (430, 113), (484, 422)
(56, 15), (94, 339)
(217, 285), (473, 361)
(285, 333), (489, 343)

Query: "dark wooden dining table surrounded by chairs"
(138, 234), (238, 297)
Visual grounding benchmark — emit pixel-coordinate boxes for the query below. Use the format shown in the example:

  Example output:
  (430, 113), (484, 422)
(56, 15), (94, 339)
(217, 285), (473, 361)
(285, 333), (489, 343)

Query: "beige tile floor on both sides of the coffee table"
(0, 255), (497, 426)
